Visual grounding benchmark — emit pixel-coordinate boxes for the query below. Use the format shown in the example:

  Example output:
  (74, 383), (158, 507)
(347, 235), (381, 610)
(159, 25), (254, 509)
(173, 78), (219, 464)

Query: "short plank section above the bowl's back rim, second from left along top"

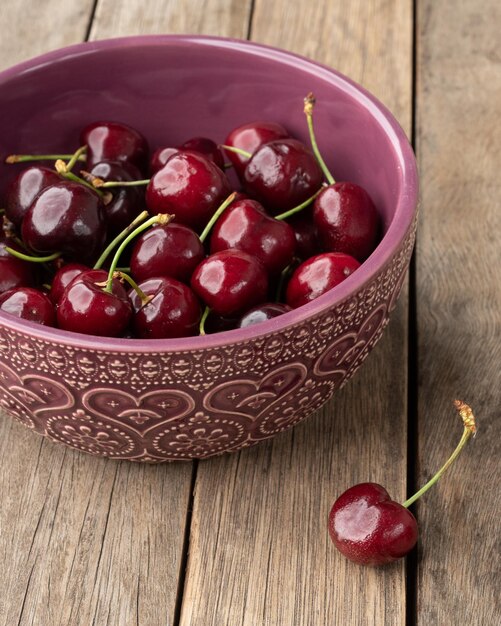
(91, 0), (251, 39)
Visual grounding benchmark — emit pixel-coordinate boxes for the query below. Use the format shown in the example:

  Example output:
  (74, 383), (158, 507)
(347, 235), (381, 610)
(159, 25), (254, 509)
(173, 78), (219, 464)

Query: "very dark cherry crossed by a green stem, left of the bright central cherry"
(86, 161), (145, 240)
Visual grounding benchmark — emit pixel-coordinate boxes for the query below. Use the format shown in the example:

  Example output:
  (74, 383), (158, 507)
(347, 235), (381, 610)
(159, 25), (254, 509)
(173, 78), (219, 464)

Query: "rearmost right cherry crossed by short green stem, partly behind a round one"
(224, 121), (289, 178)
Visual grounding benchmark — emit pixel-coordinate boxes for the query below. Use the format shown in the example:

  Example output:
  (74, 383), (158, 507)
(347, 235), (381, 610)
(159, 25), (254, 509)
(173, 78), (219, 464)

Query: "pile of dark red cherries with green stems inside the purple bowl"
(0, 94), (380, 338)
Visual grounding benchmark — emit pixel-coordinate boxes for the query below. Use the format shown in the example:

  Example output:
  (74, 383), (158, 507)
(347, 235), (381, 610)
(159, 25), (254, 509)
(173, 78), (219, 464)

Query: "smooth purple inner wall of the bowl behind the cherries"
(0, 36), (416, 346)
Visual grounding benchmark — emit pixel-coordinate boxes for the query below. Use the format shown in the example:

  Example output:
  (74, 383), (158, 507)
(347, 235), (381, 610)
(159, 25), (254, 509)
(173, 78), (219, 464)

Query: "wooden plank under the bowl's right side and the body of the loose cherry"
(181, 0), (412, 626)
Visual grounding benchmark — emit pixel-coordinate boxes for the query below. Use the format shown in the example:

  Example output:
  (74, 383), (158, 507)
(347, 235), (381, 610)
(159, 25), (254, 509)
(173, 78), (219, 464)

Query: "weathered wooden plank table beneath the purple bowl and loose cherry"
(0, 0), (501, 626)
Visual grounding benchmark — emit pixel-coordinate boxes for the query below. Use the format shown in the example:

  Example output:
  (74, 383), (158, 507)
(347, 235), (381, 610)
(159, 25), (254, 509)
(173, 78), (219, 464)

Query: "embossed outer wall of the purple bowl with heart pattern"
(0, 221), (416, 462)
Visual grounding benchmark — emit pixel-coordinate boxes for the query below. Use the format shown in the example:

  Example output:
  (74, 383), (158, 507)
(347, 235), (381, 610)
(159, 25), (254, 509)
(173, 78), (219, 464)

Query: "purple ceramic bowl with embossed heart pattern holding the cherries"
(0, 36), (417, 462)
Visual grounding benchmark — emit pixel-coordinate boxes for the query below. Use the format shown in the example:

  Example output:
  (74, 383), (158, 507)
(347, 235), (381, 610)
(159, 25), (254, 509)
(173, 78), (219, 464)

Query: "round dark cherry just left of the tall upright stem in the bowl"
(244, 139), (323, 215)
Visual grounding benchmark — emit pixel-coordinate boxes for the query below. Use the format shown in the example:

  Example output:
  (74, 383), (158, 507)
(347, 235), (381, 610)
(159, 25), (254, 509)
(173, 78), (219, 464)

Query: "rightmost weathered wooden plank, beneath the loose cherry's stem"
(417, 0), (501, 626)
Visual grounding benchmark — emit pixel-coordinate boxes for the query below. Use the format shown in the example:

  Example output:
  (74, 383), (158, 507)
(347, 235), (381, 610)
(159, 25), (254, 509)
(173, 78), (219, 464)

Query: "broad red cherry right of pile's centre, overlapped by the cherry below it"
(210, 199), (296, 276)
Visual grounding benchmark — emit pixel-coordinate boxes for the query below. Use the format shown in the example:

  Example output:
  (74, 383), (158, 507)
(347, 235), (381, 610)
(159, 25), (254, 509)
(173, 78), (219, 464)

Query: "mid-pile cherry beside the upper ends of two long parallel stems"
(130, 222), (205, 283)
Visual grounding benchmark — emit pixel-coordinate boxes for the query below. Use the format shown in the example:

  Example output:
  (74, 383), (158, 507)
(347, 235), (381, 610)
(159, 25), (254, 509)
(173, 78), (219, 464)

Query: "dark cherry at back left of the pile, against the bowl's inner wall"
(80, 121), (148, 172)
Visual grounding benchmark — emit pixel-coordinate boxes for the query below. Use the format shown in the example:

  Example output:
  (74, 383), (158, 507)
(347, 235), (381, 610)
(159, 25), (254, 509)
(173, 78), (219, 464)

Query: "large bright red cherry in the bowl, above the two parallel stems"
(146, 152), (230, 231)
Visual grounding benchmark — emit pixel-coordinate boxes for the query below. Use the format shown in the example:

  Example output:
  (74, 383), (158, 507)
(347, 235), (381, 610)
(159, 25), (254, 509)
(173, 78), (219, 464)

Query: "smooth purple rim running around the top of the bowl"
(0, 35), (419, 353)
